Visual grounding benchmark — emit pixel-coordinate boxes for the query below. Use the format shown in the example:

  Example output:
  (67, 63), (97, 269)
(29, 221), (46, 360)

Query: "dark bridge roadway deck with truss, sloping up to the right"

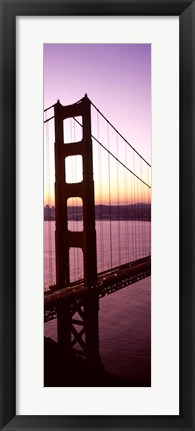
(44, 256), (151, 322)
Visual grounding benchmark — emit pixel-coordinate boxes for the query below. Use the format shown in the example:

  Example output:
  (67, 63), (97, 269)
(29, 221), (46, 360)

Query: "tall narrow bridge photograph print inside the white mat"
(44, 42), (151, 387)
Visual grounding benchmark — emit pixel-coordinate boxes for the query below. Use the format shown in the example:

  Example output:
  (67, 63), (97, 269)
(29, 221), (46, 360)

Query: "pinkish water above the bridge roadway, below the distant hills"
(44, 220), (151, 290)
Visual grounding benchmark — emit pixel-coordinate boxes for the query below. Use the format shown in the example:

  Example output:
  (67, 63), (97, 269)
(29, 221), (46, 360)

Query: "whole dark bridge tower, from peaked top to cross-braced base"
(54, 95), (100, 366)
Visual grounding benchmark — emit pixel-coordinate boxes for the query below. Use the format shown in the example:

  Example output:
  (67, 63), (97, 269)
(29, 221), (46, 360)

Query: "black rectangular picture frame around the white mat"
(0, 0), (195, 431)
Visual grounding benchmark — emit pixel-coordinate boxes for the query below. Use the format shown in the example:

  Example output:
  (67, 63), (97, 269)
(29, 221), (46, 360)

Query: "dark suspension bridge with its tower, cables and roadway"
(44, 95), (151, 370)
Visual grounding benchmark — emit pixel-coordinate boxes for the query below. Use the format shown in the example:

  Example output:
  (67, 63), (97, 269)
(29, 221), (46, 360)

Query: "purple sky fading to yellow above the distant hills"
(44, 44), (151, 207)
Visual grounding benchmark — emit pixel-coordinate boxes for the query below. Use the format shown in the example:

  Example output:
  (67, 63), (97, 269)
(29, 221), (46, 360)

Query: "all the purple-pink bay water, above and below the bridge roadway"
(44, 221), (151, 386)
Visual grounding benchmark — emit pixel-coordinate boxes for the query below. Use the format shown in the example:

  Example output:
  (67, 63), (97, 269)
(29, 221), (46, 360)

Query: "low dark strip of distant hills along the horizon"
(44, 202), (151, 221)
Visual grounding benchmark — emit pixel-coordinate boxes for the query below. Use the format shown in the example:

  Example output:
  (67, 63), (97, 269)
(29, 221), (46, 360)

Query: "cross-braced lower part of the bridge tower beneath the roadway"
(57, 290), (101, 368)
